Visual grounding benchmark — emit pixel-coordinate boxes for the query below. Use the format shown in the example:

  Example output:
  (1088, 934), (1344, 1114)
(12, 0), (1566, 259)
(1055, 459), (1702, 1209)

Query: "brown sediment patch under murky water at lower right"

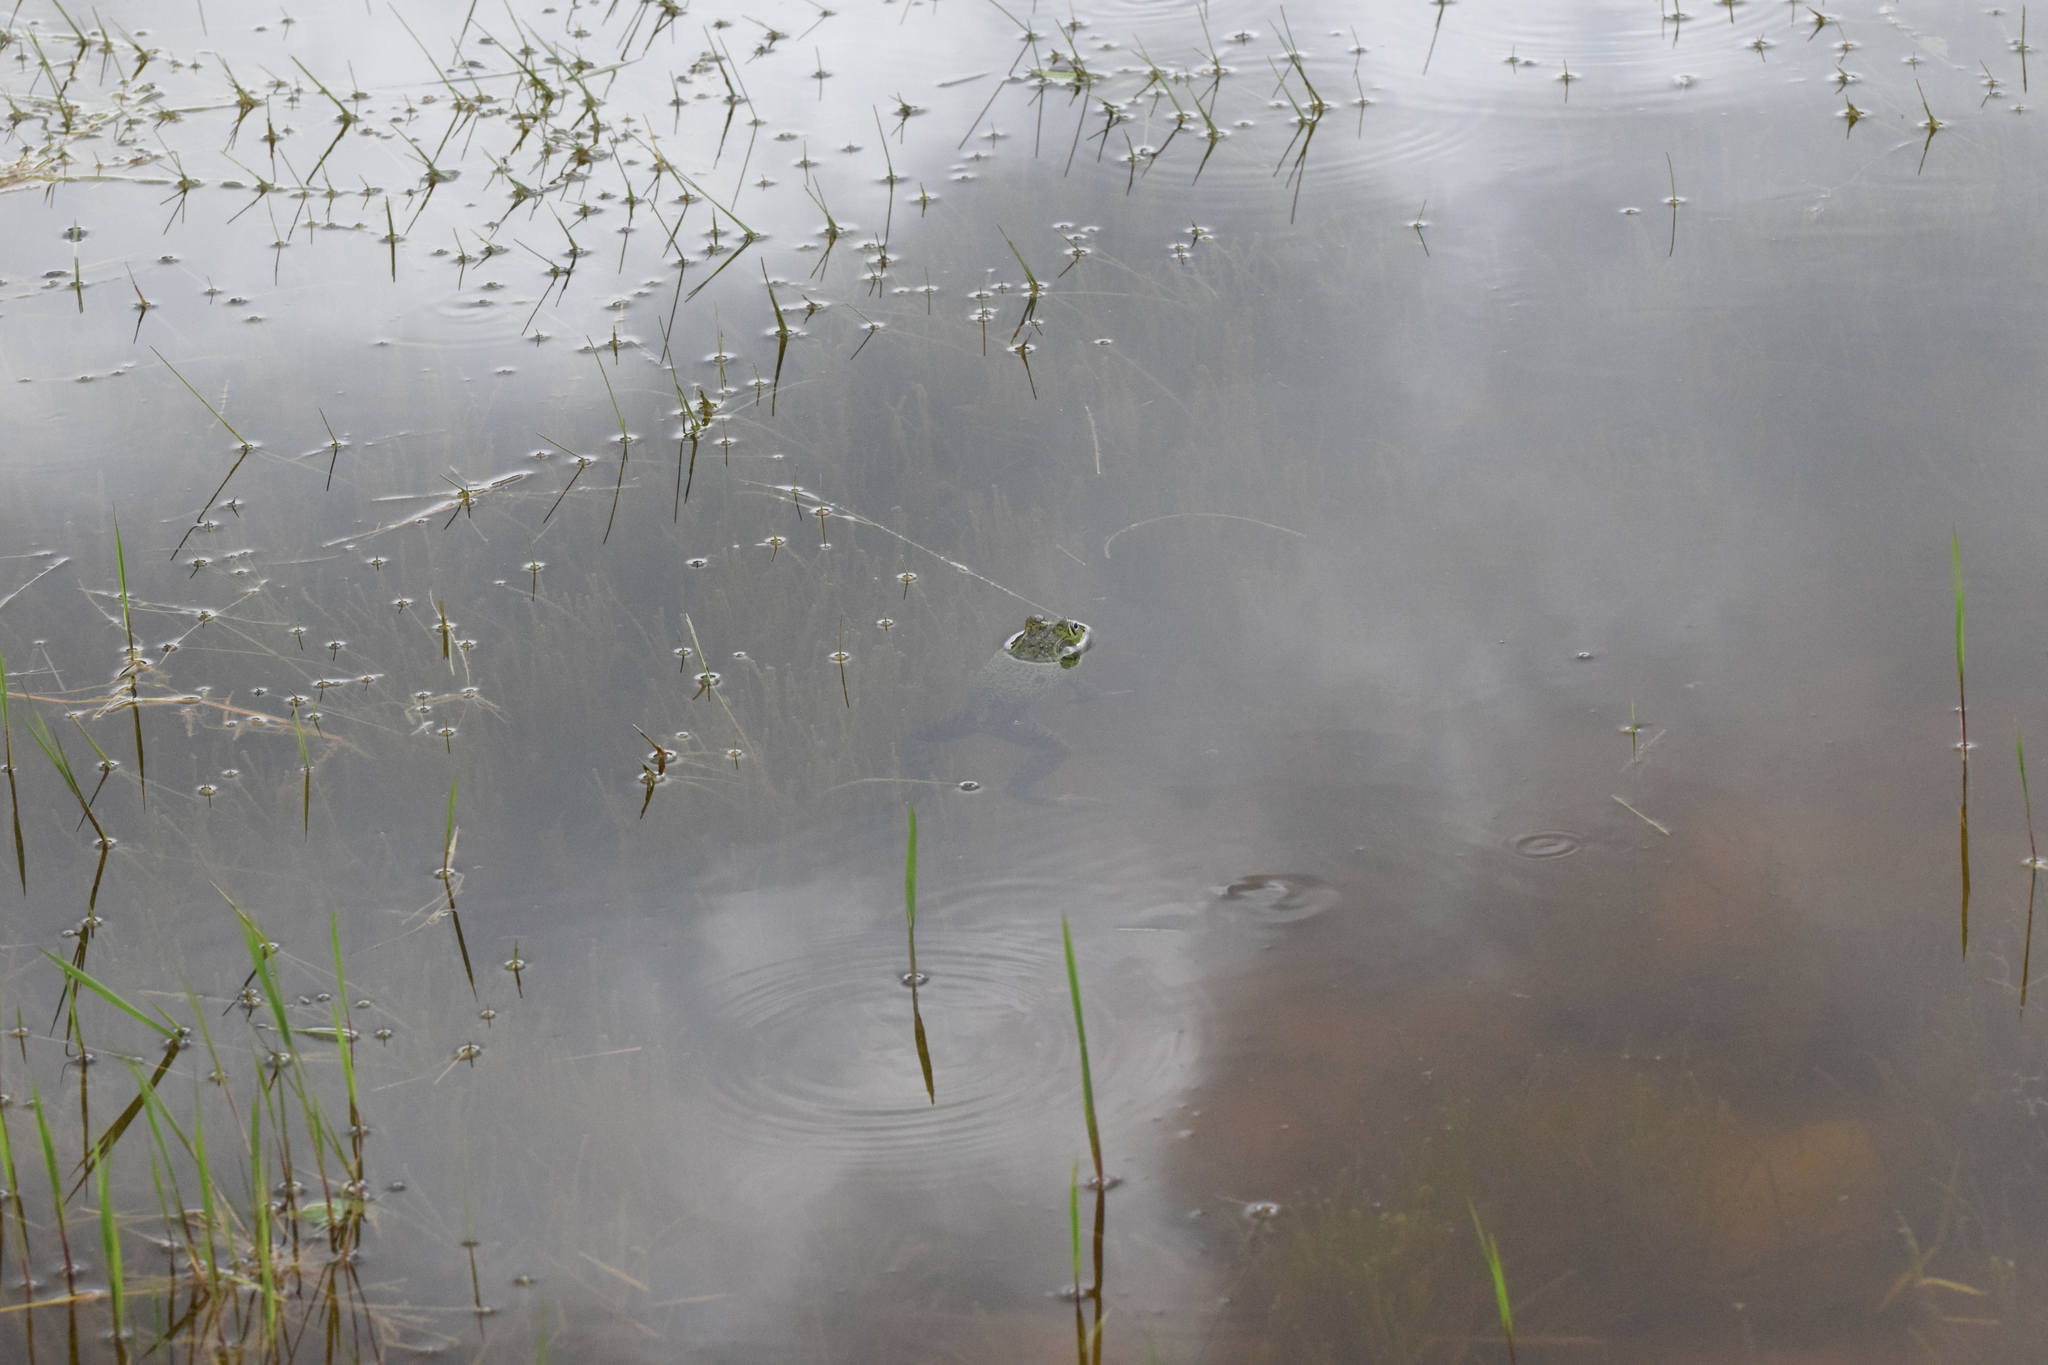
(1176, 798), (1925, 1363)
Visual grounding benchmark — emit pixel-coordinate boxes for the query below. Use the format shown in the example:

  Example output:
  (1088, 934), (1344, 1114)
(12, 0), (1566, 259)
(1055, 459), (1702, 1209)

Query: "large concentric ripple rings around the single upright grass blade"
(705, 882), (1194, 1171)
